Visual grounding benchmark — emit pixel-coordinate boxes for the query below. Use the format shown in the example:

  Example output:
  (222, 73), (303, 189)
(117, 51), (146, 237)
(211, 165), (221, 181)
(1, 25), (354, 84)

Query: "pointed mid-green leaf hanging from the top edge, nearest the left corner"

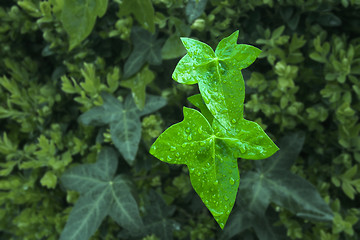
(60, 0), (108, 50)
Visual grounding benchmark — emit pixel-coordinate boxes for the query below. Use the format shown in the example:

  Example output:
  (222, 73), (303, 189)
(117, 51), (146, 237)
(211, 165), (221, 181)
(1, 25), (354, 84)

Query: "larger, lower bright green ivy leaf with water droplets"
(150, 107), (278, 228)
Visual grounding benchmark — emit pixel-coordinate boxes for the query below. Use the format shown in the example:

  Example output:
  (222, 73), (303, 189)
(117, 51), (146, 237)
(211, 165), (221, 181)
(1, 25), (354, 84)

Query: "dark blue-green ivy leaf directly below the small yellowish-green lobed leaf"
(79, 93), (166, 165)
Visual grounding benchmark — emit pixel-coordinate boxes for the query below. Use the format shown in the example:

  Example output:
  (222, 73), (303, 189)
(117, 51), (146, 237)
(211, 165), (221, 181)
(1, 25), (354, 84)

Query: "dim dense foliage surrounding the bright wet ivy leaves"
(0, 0), (360, 240)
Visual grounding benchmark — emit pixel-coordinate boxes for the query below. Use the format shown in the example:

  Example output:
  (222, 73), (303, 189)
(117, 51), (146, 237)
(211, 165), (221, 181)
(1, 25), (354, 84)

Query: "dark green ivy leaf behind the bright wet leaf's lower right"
(224, 133), (333, 239)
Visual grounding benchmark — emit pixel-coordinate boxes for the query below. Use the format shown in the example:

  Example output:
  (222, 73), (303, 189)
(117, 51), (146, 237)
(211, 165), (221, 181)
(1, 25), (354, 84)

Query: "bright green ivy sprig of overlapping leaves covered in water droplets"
(150, 31), (279, 229)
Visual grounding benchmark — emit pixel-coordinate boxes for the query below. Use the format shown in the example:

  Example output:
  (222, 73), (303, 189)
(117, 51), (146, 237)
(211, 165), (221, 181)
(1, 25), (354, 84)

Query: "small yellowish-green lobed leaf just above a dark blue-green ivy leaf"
(120, 66), (155, 110)
